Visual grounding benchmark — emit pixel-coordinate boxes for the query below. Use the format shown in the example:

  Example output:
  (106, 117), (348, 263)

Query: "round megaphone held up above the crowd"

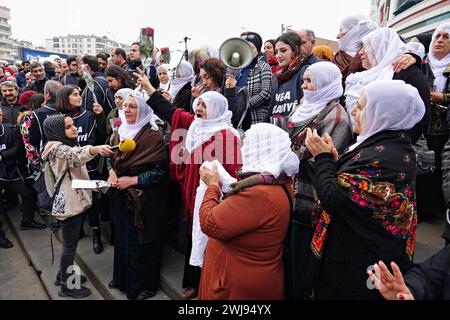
(219, 38), (253, 72)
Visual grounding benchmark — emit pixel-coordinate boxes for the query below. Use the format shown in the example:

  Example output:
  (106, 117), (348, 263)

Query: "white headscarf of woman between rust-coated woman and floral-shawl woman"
(289, 61), (344, 124)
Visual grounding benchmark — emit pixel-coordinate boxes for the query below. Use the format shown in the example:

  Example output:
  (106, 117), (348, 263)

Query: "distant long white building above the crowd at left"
(45, 35), (130, 55)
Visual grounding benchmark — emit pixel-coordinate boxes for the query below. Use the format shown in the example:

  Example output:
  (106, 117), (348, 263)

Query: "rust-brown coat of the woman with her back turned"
(199, 184), (292, 300)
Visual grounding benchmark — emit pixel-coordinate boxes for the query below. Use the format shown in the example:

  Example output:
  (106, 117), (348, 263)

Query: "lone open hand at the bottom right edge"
(367, 261), (415, 300)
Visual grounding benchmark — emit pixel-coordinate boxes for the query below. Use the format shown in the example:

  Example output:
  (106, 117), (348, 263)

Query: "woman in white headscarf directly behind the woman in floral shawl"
(345, 28), (430, 144)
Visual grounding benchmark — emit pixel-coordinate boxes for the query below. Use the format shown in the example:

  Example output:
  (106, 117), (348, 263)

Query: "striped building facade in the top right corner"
(371, 0), (450, 39)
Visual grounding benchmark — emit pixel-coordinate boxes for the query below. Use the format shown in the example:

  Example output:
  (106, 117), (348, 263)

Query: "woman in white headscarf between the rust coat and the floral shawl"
(286, 62), (353, 299)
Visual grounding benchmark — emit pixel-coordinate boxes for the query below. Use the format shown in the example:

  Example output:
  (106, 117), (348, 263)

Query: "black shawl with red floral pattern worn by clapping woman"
(312, 131), (417, 259)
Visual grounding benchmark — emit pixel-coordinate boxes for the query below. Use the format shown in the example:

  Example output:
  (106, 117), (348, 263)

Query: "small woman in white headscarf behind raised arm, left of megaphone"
(169, 59), (194, 112)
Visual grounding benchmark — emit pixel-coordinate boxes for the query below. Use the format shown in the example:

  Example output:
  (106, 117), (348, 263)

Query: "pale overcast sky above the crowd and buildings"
(0, 0), (370, 63)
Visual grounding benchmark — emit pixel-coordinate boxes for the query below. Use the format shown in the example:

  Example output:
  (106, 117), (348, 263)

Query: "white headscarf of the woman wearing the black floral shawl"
(350, 80), (425, 151)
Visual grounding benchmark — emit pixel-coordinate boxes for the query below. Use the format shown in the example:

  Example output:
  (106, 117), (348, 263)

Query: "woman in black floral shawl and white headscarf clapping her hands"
(306, 80), (425, 299)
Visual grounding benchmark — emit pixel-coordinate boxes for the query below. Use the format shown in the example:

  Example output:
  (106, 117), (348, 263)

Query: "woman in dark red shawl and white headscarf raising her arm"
(138, 75), (242, 299)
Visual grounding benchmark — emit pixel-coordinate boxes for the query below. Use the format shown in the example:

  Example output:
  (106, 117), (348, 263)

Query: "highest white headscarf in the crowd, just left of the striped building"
(338, 16), (378, 57)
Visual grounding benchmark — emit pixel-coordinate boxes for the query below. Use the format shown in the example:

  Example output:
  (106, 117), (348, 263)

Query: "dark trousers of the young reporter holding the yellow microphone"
(59, 214), (84, 284)
